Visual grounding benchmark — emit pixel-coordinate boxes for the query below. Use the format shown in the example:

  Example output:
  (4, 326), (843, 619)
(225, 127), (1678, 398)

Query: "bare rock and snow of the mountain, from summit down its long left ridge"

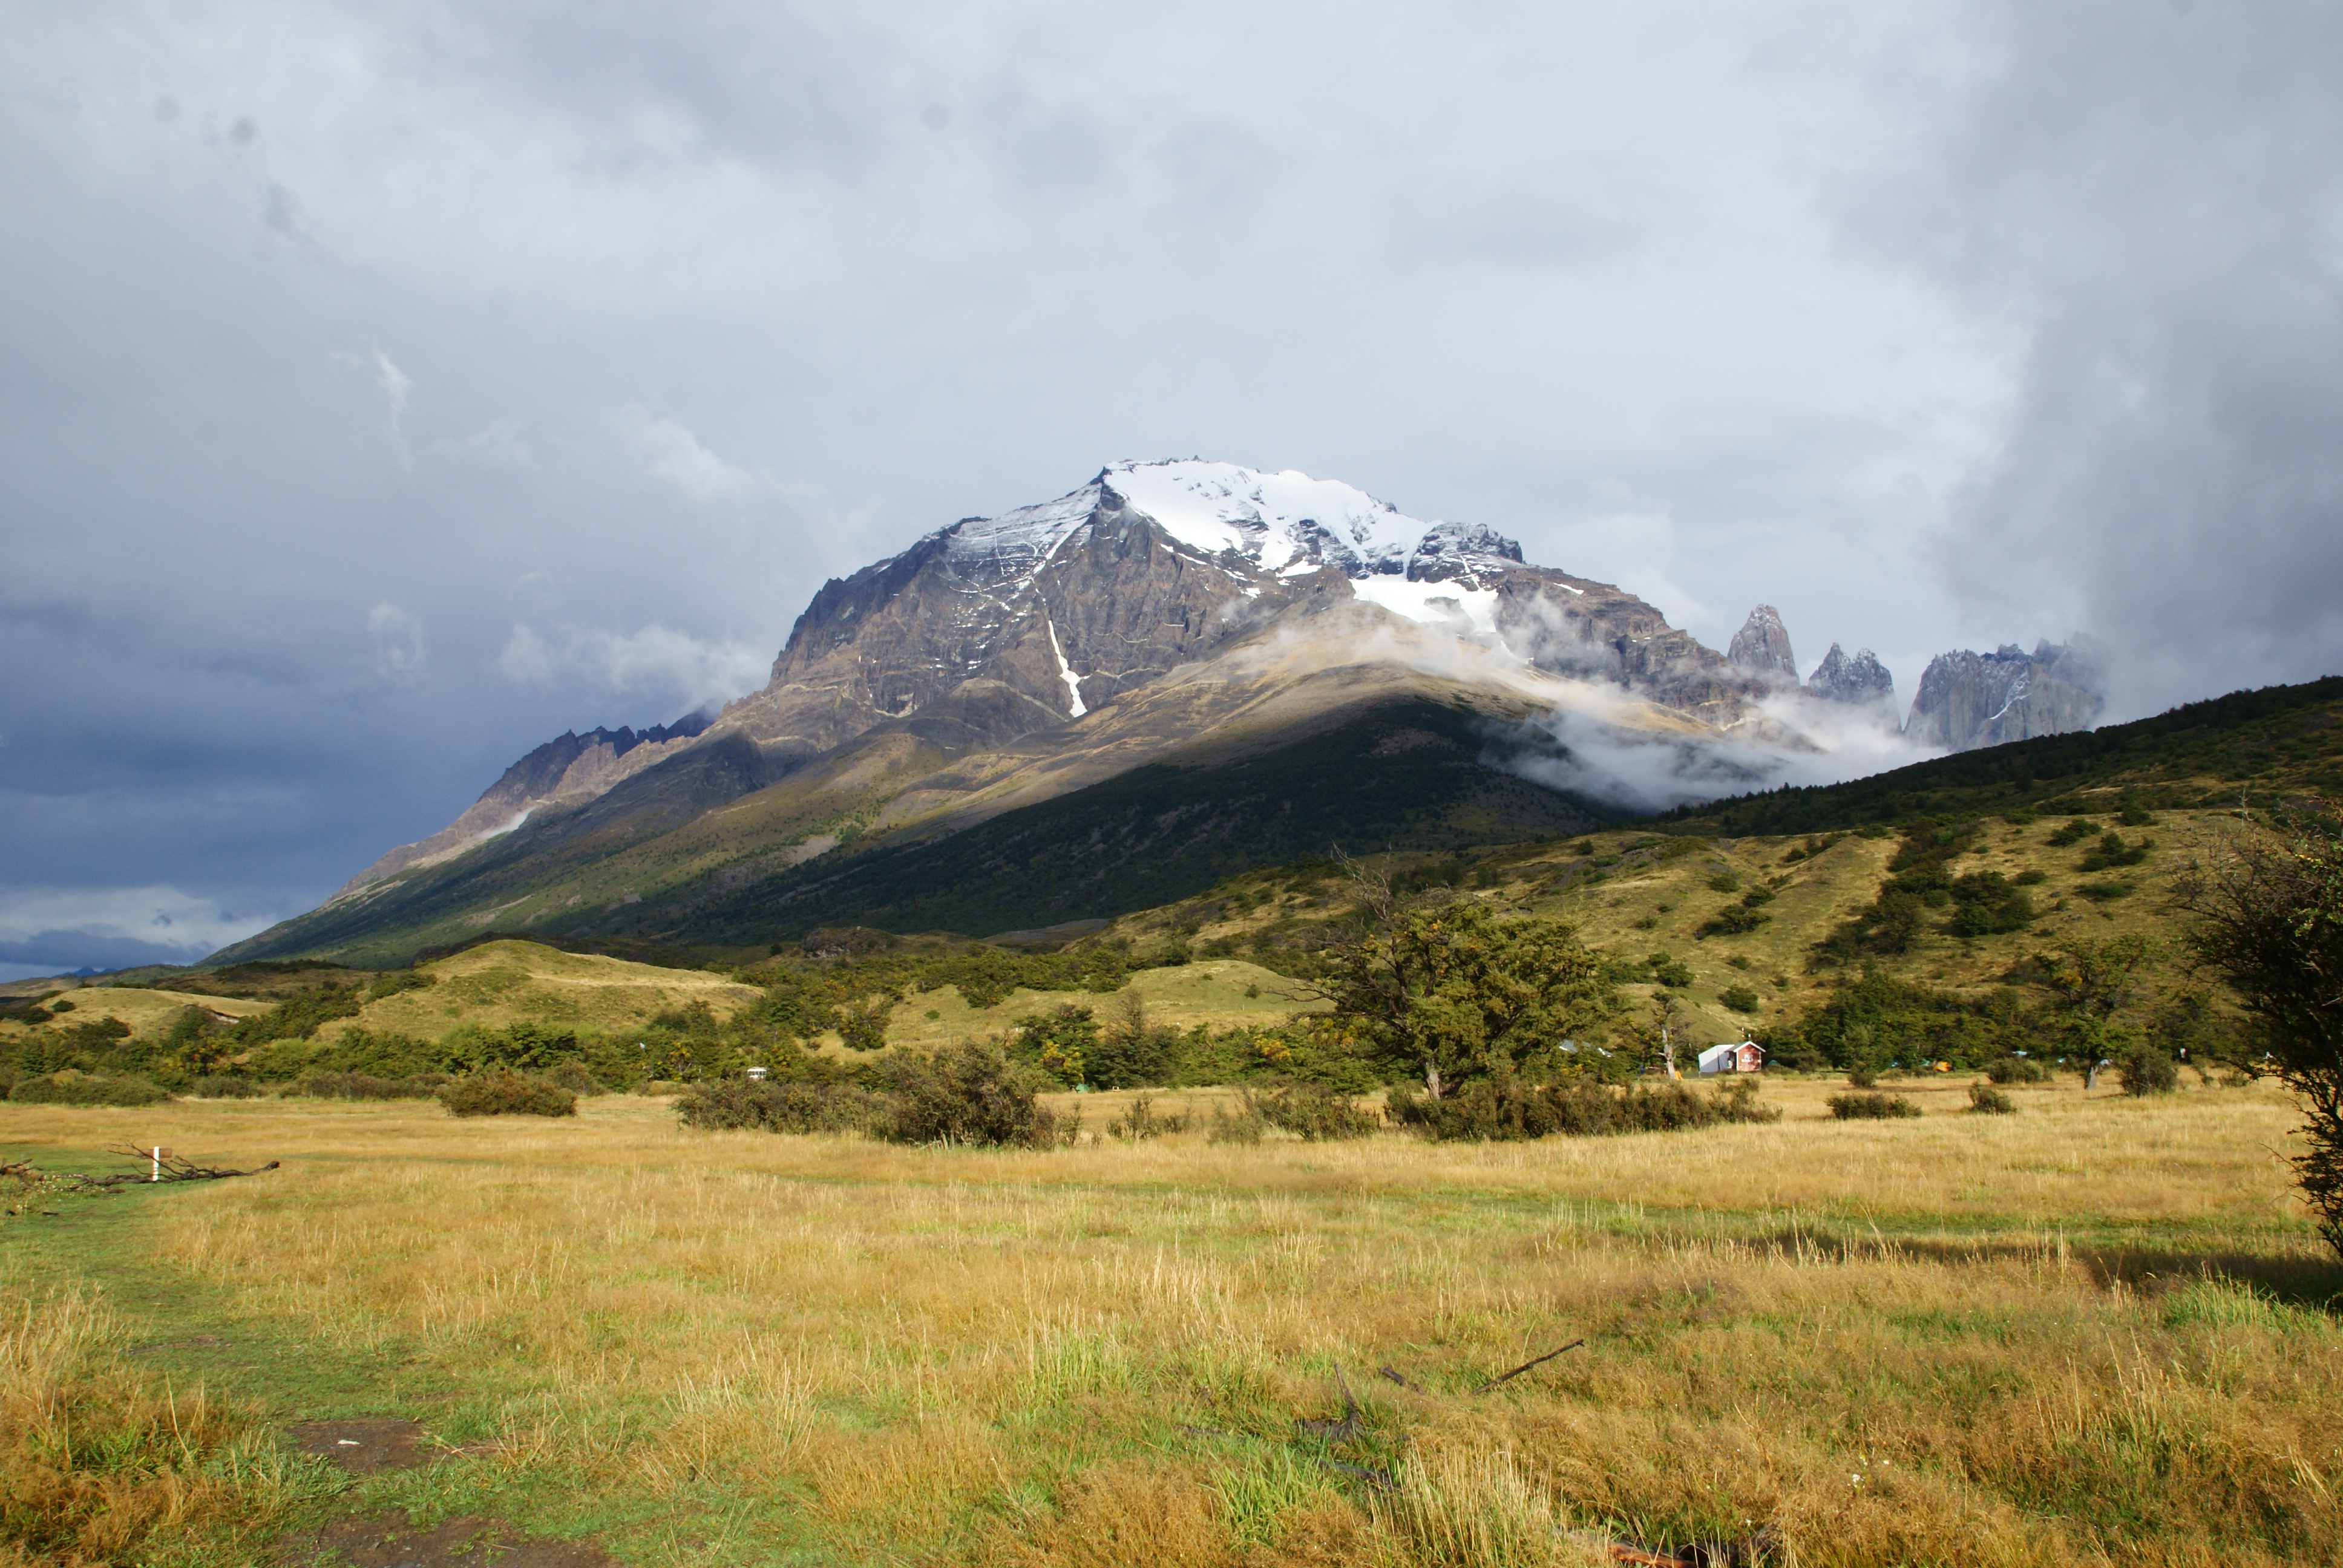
(316, 462), (1762, 898)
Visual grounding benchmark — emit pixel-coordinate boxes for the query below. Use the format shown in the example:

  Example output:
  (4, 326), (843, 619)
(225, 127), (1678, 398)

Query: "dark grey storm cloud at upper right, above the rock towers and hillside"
(1876, 0), (2343, 710)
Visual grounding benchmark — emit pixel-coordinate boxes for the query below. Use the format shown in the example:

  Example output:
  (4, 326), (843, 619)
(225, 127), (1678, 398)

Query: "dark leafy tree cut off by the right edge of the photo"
(2177, 802), (2343, 1252)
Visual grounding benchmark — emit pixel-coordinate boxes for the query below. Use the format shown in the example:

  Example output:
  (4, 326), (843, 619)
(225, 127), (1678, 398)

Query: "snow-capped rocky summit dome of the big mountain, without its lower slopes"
(719, 462), (1746, 759)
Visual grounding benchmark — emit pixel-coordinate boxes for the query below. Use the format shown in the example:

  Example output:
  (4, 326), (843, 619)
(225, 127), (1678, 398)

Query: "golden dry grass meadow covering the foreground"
(0, 1080), (2343, 1568)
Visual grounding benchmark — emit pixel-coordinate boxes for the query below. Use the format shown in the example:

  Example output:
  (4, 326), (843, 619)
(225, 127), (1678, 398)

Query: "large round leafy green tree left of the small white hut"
(1312, 872), (1617, 1099)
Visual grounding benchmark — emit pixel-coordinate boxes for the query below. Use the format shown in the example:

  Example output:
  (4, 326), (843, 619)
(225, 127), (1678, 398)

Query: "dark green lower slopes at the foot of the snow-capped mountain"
(220, 701), (1619, 965)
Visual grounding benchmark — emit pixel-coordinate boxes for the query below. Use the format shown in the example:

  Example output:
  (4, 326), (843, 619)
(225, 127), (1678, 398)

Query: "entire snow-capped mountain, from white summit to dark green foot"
(223, 459), (2118, 961)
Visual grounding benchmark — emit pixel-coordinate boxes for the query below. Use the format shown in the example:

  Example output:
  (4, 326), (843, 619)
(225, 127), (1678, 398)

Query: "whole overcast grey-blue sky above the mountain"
(0, 0), (2343, 975)
